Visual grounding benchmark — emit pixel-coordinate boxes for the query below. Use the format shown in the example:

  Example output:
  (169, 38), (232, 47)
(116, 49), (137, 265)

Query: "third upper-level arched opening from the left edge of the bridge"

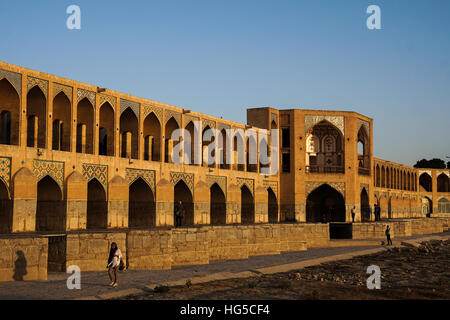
(52, 92), (71, 151)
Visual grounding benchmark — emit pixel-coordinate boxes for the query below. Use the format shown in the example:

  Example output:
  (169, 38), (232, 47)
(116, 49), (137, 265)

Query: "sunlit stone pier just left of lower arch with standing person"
(155, 179), (174, 227)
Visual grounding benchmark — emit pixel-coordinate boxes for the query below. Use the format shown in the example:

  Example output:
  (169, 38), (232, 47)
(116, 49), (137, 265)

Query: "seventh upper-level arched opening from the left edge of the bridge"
(144, 112), (161, 161)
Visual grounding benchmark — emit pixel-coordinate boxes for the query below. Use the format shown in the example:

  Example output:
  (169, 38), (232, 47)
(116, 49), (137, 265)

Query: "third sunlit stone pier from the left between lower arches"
(108, 176), (129, 229)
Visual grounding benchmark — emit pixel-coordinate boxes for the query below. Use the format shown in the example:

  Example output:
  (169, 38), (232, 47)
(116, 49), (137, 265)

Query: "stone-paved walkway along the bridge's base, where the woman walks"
(0, 232), (450, 300)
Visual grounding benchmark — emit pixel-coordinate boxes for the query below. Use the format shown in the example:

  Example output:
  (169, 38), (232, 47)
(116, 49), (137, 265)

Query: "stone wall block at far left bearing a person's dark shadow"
(0, 236), (48, 281)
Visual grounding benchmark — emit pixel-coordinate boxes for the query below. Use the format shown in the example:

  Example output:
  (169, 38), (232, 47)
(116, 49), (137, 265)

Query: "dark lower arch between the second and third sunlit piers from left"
(86, 178), (108, 230)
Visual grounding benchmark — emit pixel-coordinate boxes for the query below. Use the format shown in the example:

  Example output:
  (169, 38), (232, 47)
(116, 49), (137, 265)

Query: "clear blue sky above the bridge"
(0, 0), (450, 165)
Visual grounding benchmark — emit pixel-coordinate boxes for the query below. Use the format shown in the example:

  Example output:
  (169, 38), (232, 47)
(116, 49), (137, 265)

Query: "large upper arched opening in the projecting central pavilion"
(306, 120), (345, 173)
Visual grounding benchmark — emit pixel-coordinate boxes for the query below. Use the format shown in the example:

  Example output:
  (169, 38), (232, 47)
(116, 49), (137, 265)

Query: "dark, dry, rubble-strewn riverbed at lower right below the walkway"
(114, 240), (450, 300)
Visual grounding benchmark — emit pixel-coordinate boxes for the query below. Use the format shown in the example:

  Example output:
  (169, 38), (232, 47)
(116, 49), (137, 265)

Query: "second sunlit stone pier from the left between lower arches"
(66, 171), (87, 231)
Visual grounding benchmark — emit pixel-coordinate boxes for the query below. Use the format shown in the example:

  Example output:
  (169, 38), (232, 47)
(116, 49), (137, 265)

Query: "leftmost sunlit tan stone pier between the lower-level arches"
(12, 167), (37, 232)
